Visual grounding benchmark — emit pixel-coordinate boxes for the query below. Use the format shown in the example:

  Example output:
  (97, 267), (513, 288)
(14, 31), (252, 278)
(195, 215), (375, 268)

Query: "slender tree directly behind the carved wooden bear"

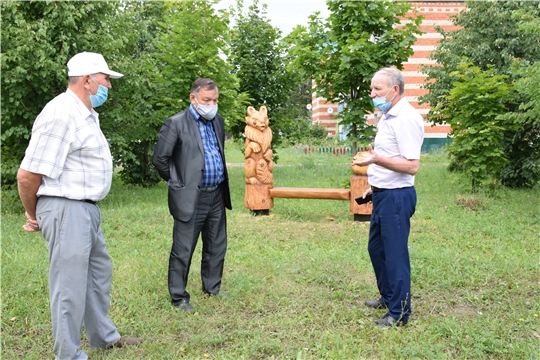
(229, 0), (305, 146)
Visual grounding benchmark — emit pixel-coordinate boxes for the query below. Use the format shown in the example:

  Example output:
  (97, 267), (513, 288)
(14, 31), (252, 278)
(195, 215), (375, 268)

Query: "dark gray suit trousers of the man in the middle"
(169, 186), (227, 305)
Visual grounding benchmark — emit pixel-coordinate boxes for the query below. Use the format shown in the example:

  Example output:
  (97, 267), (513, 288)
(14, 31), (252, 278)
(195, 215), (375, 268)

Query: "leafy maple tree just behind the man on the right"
(287, 0), (421, 150)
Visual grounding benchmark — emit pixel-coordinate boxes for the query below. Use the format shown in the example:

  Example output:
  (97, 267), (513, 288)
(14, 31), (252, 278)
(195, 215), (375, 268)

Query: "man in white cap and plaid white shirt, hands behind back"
(17, 52), (142, 359)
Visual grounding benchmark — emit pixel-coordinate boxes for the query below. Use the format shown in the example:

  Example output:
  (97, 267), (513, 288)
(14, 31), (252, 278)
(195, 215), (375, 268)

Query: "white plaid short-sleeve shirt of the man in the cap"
(21, 89), (113, 201)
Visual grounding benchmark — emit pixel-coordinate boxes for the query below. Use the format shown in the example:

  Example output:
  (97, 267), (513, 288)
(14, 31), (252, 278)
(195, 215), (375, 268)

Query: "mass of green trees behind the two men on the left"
(1, 1), (251, 187)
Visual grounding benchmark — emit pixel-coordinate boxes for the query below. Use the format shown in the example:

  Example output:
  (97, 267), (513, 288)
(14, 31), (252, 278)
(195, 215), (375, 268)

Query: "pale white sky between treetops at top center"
(215, 0), (329, 36)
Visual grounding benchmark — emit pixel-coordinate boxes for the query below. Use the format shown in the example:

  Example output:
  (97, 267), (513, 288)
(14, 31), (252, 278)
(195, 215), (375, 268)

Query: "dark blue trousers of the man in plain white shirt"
(368, 186), (416, 320)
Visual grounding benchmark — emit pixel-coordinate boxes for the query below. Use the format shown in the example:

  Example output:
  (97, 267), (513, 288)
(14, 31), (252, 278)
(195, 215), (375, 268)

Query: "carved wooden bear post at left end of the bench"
(244, 106), (274, 210)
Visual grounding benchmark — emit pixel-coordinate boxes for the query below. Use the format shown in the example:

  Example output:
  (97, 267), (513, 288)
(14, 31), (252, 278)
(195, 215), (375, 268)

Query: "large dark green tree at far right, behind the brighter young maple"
(421, 1), (540, 187)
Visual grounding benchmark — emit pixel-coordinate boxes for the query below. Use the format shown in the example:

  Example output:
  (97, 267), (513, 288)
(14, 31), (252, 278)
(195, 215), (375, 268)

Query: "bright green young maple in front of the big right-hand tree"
(433, 64), (517, 190)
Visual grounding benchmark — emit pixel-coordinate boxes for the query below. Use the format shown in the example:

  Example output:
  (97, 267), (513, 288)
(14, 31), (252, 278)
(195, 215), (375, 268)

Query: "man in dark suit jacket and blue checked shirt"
(152, 78), (231, 312)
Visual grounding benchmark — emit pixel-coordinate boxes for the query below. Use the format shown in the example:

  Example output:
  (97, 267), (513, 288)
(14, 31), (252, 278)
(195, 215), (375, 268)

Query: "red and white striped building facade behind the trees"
(311, 1), (466, 139)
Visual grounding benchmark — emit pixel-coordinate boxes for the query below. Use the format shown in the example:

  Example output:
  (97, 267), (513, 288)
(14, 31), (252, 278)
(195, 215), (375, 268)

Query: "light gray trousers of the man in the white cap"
(37, 196), (120, 359)
